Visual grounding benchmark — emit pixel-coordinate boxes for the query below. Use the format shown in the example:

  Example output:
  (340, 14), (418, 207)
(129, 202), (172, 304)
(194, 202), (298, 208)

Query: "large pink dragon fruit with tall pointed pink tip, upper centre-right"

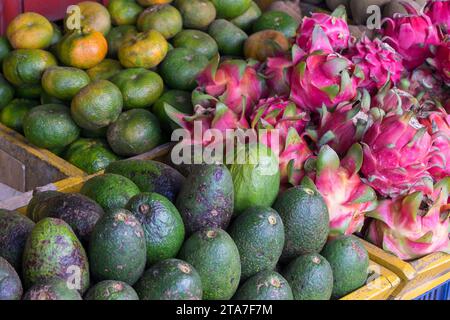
(291, 25), (364, 112)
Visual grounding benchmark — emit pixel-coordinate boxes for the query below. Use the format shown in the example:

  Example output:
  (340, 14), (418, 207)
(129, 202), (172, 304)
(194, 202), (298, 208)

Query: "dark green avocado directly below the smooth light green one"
(228, 207), (284, 279)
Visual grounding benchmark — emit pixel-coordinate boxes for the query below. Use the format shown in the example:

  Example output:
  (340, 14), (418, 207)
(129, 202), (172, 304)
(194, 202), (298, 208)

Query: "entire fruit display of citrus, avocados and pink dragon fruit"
(0, 0), (450, 301)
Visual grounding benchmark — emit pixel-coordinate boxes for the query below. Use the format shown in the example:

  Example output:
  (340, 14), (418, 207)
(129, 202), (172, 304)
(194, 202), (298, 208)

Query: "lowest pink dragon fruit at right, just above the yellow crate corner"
(366, 177), (450, 260)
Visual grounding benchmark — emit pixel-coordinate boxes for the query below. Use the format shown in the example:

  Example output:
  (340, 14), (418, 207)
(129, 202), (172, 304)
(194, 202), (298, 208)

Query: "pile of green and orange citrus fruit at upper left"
(0, 0), (298, 173)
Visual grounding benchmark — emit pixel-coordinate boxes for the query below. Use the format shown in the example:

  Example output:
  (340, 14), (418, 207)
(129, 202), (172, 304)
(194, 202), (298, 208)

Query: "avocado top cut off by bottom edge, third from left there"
(84, 280), (139, 300)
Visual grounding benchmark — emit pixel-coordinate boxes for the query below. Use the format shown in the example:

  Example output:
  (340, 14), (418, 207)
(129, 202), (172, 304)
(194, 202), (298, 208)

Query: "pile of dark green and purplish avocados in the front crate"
(0, 160), (369, 300)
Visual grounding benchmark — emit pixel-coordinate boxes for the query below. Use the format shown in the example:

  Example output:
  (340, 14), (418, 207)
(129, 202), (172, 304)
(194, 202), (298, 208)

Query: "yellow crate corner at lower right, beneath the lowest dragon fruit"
(364, 241), (450, 300)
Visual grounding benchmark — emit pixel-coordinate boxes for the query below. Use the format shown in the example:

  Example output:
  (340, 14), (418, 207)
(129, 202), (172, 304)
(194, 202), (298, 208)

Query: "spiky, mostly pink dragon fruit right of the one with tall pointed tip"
(347, 37), (404, 93)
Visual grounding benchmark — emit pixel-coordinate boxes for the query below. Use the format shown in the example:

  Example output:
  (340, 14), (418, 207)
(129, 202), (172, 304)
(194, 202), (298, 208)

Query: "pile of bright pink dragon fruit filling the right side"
(171, 1), (450, 260)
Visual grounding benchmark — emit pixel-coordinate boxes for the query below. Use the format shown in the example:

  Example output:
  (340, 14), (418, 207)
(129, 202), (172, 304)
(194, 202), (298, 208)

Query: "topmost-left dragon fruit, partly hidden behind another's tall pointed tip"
(296, 5), (350, 52)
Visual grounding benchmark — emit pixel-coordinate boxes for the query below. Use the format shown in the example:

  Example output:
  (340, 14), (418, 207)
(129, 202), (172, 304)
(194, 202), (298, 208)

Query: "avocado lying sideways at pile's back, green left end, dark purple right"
(105, 160), (184, 202)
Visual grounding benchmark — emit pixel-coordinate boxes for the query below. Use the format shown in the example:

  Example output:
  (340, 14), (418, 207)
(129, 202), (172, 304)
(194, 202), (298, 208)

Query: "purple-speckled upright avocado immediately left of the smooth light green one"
(175, 164), (234, 234)
